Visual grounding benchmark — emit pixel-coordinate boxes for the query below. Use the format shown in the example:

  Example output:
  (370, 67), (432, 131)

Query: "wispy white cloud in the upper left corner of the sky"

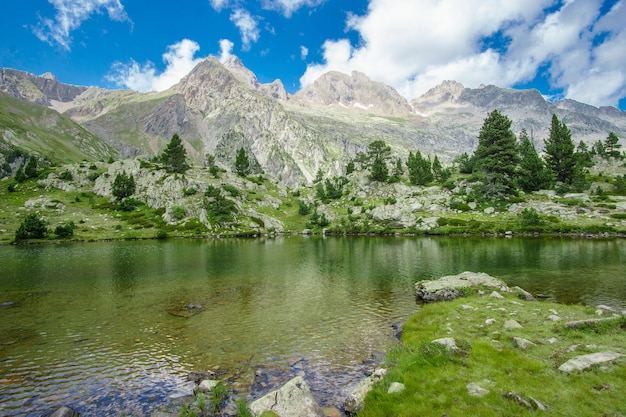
(33, 0), (130, 50)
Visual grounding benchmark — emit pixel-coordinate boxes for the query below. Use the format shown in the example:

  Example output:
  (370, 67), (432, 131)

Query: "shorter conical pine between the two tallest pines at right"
(517, 129), (552, 192)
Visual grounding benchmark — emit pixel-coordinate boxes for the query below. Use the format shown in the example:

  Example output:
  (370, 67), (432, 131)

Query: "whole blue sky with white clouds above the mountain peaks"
(0, 0), (626, 110)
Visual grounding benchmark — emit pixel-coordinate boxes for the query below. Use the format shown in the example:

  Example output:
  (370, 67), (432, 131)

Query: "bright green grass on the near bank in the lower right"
(359, 295), (626, 417)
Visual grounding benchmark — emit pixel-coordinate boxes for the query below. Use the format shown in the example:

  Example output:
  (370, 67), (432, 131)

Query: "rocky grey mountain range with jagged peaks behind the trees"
(0, 56), (626, 186)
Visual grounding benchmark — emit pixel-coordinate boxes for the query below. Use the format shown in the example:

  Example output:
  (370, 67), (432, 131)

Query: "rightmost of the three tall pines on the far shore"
(545, 114), (576, 184)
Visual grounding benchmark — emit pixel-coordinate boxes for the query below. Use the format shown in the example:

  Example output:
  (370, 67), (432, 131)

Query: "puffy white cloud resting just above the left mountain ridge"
(107, 39), (204, 92)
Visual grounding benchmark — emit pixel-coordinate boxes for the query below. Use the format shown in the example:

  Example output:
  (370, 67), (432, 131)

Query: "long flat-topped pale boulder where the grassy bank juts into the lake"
(415, 271), (509, 303)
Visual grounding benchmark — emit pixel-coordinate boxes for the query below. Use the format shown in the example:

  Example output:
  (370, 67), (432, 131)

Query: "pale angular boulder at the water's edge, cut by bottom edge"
(249, 376), (324, 417)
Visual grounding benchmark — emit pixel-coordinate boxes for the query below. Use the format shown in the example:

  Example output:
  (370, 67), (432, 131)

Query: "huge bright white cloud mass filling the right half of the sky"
(300, 0), (626, 109)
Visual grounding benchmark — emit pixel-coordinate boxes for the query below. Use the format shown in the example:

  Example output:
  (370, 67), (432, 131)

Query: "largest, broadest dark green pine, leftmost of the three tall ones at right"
(474, 110), (519, 194)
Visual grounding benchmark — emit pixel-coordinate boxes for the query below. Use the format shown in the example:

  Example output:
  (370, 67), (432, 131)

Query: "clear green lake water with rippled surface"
(0, 237), (626, 416)
